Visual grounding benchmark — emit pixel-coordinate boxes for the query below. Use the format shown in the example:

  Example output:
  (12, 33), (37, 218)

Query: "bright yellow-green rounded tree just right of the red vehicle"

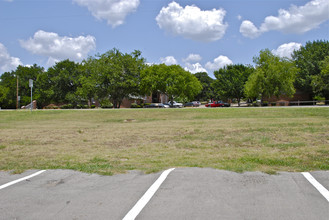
(245, 49), (297, 103)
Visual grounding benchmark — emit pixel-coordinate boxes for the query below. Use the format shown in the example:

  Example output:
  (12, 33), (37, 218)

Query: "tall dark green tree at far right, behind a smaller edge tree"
(292, 40), (329, 99)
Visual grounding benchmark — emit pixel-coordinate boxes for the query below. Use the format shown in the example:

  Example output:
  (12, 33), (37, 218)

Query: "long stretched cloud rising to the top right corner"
(240, 0), (329, 38)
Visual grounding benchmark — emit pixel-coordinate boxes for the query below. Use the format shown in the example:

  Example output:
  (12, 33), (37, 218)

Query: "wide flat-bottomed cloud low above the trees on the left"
(20, 30), (96, 65)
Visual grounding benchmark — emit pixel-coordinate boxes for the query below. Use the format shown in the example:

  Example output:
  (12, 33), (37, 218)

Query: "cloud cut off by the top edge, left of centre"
(73, 0), (140, 27)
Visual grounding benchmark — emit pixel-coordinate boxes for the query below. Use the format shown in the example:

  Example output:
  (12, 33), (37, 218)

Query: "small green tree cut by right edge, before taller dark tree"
(312, 56), (329, 104)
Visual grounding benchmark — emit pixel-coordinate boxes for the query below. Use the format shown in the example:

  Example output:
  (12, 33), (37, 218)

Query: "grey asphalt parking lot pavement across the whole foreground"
(0, 168), (329, 220)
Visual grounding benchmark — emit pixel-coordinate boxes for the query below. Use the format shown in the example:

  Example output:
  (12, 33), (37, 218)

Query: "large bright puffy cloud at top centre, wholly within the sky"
(156, 2), (228, 42)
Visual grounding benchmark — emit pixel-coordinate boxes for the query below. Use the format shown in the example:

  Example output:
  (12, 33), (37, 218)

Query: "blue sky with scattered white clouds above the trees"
(0, 0), (329, 76)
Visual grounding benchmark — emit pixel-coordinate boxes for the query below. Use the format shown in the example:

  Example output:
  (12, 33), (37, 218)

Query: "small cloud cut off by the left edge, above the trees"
(0, 43), (22, 72)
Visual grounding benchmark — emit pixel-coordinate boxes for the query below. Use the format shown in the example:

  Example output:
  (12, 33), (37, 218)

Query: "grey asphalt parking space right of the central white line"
(137, 168), (329, 219)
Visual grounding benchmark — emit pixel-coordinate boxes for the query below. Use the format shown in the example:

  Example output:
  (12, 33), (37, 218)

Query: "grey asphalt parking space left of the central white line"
(0, 170), (159, 220)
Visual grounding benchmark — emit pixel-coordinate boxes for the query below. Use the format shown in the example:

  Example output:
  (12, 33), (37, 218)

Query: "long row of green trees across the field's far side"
(0, 40), (329, 109)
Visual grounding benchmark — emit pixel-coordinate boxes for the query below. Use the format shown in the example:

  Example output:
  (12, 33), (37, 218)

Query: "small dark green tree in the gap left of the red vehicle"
(194, 72), (216, 101)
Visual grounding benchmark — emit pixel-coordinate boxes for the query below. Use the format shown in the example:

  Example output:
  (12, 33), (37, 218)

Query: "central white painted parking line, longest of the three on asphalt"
(123, 168), (175, 220)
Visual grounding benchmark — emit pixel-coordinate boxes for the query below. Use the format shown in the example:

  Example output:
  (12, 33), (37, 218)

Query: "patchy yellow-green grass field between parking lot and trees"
(0, 107), (329, 175)
